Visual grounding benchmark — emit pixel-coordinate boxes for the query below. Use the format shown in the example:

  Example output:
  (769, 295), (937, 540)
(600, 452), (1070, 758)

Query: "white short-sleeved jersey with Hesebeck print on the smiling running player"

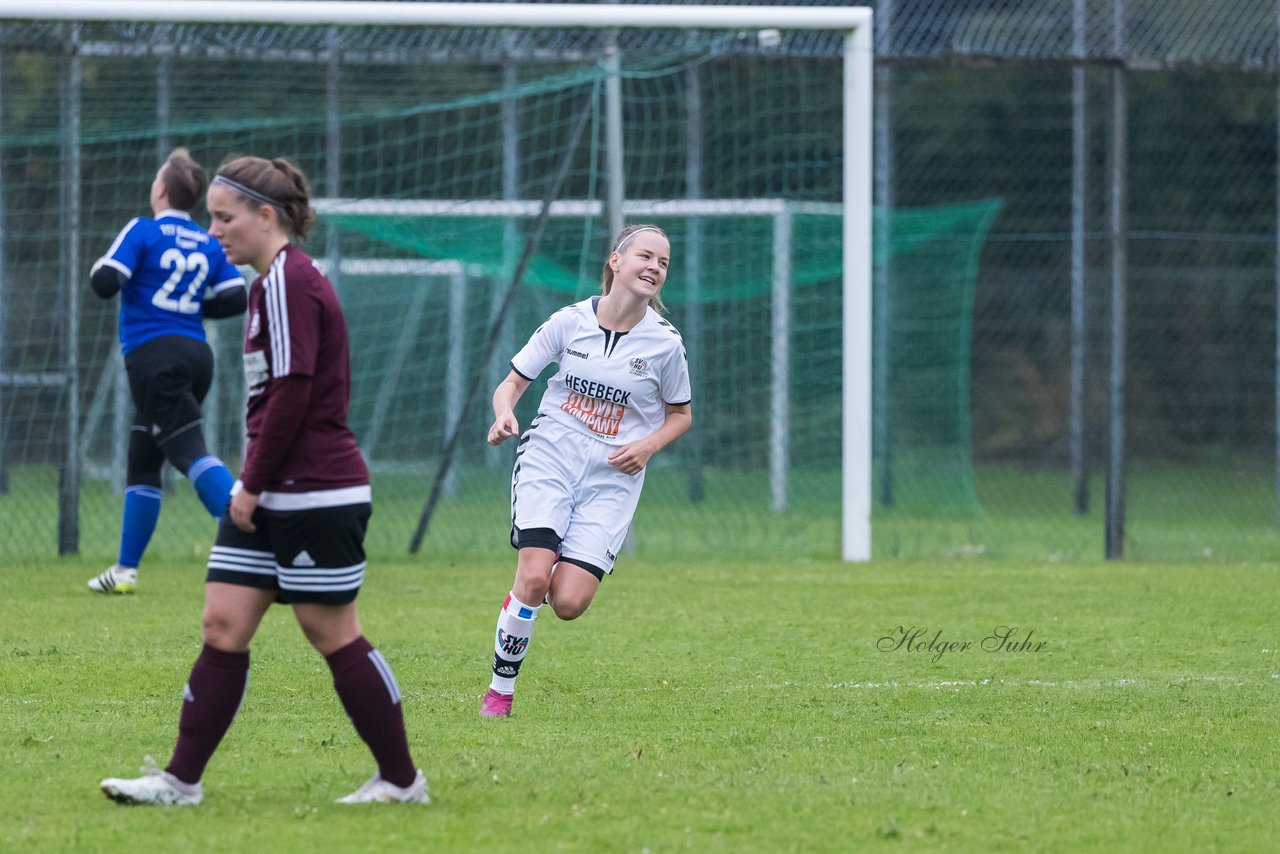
(511, 297), (691, 446)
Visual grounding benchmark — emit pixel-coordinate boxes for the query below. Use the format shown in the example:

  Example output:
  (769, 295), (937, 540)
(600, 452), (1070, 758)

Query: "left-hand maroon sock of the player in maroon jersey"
(165, 644), (248, 784)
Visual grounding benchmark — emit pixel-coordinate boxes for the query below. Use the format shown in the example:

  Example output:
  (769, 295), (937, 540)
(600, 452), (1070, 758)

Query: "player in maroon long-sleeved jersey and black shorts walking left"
(101, 157), (429, 804)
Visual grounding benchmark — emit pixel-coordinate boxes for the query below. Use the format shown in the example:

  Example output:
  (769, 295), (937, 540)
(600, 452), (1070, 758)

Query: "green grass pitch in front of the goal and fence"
(0, 553), (1280, 851)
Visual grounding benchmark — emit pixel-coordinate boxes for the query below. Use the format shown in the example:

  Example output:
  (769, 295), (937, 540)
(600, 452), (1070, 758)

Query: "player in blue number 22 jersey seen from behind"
(88, 149), (246, 593)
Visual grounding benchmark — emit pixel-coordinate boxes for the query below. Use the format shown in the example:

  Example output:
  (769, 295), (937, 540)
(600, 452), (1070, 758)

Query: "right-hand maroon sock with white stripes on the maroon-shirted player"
(325, 636), (417, 787)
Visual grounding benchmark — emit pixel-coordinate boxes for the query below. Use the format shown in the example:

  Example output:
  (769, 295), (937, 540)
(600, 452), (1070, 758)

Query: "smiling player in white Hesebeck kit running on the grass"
(480, 225), (692, 717)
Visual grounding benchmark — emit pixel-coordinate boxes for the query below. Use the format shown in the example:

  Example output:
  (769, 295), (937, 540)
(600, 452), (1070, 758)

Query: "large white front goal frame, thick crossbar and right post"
(0, 0), (874, 562)
